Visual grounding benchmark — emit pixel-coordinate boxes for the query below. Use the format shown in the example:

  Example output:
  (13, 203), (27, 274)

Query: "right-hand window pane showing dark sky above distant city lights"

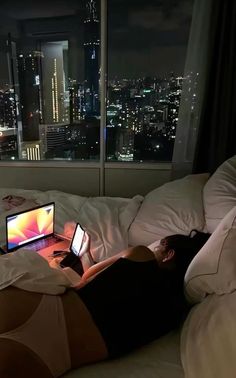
(106, 0), (193, 162)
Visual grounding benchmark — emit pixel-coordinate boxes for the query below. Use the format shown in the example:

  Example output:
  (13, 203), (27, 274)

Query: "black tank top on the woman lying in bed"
(77, 258), (185, 357)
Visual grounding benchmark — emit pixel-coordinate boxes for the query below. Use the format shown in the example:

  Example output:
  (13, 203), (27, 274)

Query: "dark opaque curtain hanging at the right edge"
(193, 0), (236, 173)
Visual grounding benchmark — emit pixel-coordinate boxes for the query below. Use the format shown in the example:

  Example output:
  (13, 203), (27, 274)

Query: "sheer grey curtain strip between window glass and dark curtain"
(171, 0), (215, 179)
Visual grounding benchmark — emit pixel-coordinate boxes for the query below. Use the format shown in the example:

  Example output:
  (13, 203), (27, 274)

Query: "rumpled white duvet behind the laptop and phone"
(0, 188), (143, 261)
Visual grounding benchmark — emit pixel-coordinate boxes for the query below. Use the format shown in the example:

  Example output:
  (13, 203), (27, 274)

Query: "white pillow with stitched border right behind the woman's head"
(185, 206), (236, 303)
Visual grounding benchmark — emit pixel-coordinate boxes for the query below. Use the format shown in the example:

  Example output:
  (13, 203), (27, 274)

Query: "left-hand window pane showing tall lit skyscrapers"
(0, 0), (100, 160)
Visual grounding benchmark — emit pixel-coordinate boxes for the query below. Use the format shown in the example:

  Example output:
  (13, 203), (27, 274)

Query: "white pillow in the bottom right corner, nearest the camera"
(181, 291), (236, 378)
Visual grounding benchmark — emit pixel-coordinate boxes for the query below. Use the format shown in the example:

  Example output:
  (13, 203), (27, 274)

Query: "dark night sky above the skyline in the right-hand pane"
(108, 0), (193, 77)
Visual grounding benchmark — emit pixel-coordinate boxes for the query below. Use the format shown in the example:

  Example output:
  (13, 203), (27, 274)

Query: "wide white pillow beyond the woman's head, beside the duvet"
(129, 173), (209, 245)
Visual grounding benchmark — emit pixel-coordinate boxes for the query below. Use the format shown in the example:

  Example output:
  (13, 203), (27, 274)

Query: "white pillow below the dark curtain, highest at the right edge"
(203, 155), (236, 233)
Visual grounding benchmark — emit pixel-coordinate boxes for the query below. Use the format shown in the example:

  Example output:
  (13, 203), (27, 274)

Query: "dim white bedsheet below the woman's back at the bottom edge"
(63, 331), (183, 378)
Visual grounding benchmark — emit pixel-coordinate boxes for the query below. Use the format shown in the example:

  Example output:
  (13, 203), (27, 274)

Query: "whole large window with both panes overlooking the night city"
(0, 0), (192, 162)
